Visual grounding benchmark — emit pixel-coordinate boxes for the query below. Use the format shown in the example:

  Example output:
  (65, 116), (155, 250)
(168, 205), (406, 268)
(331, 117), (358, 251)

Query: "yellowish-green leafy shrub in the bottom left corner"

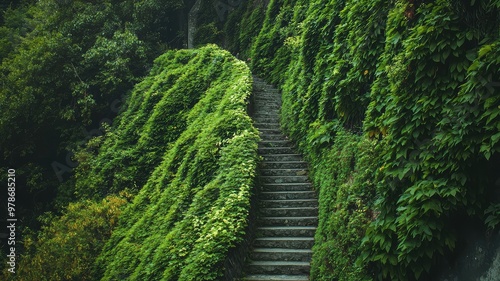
(2, 194), (127, 281)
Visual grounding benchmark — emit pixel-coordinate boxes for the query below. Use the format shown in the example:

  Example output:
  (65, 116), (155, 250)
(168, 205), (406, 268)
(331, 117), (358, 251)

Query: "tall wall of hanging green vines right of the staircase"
(225, 0), (500, 280)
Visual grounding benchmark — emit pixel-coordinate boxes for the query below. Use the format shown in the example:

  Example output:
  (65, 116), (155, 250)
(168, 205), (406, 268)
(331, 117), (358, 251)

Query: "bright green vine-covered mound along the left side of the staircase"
(95, 45), (259, 280)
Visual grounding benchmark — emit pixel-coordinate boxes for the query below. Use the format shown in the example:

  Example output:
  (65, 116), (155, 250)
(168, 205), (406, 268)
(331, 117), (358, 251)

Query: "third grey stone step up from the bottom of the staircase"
(250, 248), (312, 262)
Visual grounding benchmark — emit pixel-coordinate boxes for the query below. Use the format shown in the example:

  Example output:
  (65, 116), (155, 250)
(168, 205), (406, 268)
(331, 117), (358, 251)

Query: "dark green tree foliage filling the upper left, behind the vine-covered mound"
(0, 0), (183, 227)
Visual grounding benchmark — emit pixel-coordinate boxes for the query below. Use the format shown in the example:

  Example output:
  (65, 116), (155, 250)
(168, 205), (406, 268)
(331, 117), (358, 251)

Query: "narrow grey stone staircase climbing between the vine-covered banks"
(243, 77), (318, 281)
